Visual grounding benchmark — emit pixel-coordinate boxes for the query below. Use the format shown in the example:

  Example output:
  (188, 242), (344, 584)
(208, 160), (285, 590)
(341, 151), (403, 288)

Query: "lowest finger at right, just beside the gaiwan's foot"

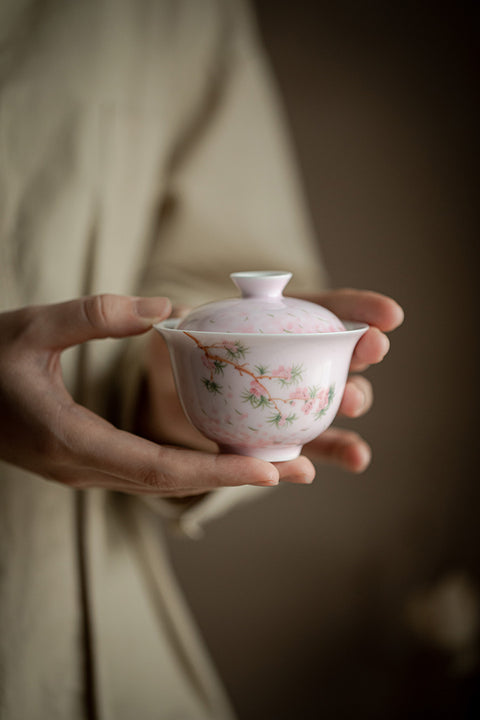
(305, 428), (372, 473)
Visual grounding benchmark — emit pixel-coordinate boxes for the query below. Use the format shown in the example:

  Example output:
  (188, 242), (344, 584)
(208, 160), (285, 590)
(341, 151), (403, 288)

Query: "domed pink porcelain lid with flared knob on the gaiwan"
(178, 271), (345, 334)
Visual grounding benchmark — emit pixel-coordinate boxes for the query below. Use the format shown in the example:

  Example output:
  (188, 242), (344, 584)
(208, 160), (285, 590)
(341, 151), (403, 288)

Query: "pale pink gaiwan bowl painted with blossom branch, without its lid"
(154, 320), (368, 461)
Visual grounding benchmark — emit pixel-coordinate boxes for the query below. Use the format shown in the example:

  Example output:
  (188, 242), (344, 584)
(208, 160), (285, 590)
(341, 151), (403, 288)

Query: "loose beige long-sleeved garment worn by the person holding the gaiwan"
(0, 0), (322, 720)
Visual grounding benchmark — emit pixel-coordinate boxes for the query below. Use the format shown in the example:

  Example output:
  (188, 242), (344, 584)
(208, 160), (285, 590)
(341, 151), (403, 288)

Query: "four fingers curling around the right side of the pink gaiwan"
(305, 289), (403, 473)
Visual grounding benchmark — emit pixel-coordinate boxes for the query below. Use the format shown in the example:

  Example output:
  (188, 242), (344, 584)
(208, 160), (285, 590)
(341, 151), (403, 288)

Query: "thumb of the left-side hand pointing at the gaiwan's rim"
(30, 295), (171, 350)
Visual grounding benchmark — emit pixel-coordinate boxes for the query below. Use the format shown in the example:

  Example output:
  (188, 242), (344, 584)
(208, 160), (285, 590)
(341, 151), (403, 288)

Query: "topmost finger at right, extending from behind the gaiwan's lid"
(316, 288), (404, 332)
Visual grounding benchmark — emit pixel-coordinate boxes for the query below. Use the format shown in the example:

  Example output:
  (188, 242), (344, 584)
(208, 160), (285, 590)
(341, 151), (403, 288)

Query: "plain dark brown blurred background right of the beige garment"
(167, 0), (480, 720)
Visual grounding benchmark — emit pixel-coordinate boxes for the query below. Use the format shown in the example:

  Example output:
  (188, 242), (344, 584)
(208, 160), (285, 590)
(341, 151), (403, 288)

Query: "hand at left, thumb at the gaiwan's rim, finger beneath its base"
(0, 295), (292, 496)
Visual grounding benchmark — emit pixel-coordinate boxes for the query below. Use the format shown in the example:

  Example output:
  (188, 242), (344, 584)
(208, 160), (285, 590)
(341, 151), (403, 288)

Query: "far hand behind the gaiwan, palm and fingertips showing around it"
(138, 289), (403, 483)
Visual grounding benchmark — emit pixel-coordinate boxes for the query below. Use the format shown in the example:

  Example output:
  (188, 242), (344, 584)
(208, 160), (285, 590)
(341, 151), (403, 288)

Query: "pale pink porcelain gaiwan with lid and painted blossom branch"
(155, 271), (368, 462)
